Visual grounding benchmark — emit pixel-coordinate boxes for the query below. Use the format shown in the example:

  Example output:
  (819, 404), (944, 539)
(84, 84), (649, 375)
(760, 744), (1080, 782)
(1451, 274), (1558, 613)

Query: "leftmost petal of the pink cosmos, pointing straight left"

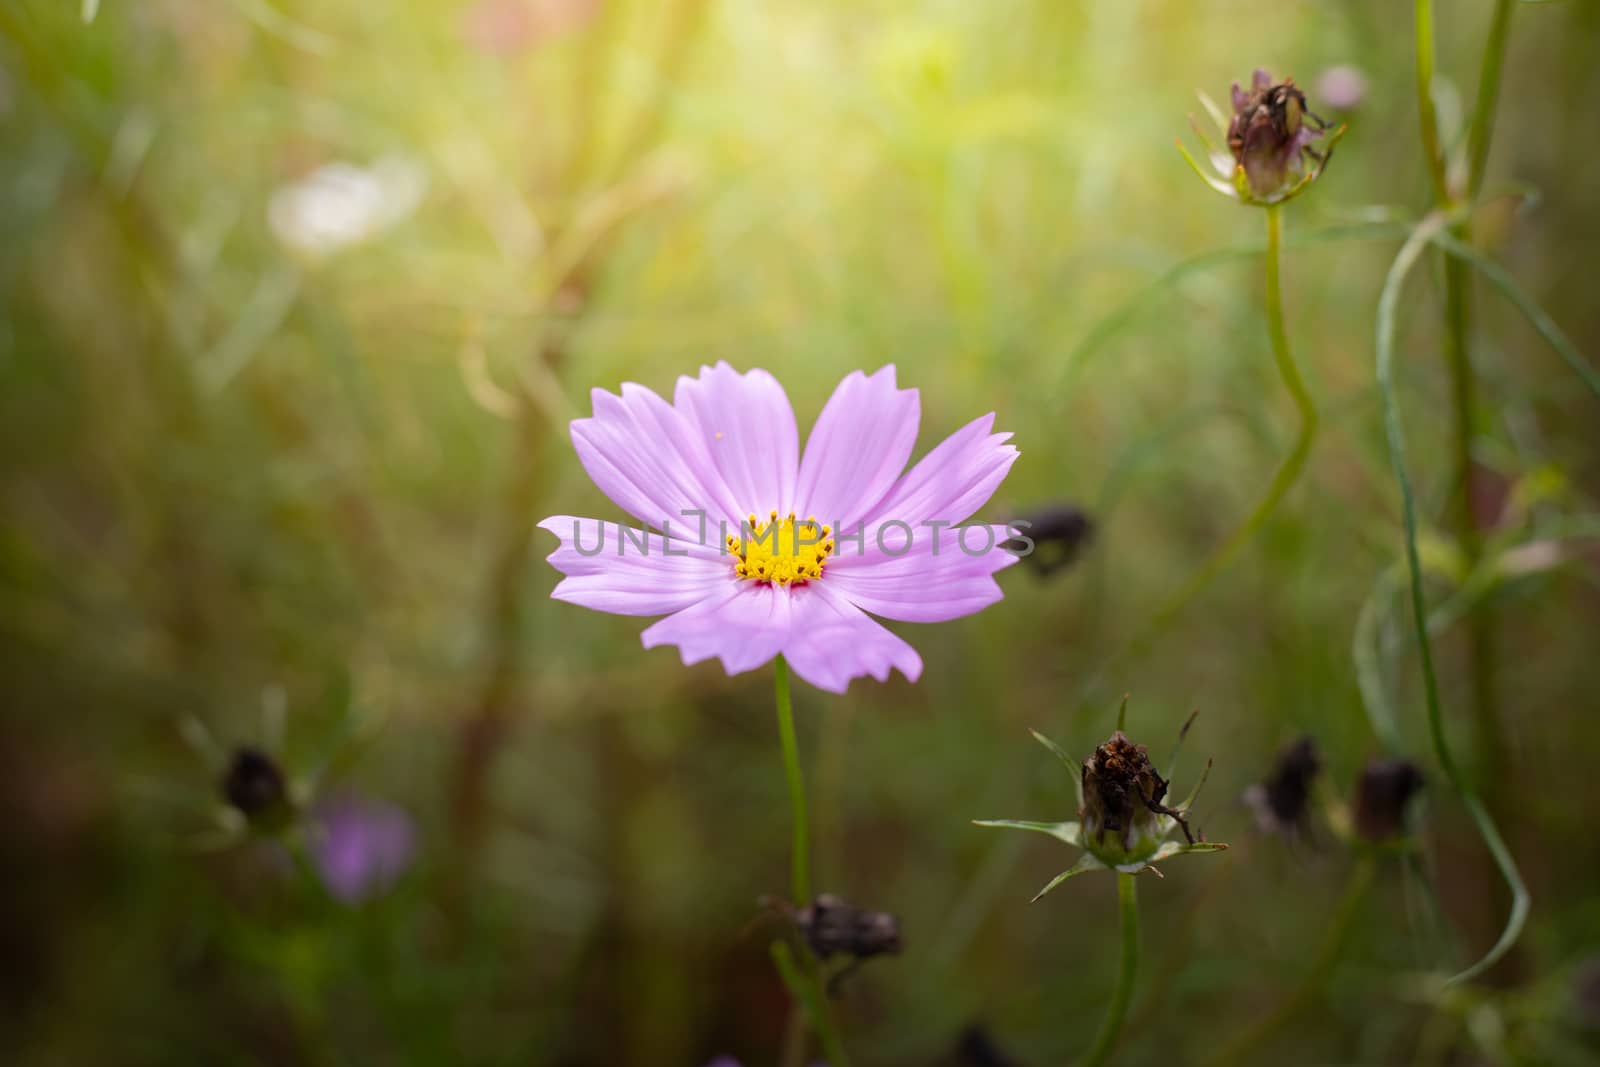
(539, 515), (733, 614)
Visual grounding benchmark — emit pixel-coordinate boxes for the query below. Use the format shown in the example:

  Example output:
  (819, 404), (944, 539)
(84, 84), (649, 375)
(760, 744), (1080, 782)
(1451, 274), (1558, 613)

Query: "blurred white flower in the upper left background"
(267, 155), (427, 256)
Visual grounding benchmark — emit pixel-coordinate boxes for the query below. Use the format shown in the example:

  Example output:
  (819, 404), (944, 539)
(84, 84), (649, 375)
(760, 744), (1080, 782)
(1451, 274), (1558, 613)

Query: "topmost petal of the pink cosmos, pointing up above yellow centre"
(672, 363), (800, 525)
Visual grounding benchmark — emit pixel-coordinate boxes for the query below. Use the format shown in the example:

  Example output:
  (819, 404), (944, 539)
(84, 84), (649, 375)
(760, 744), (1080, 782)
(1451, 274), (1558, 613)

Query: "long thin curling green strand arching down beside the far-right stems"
(1378, 213), (1530, 984)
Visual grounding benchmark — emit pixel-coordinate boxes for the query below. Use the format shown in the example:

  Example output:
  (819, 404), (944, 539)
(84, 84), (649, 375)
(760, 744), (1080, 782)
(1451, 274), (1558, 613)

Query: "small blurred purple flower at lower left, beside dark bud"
(312, 793), (416, 904)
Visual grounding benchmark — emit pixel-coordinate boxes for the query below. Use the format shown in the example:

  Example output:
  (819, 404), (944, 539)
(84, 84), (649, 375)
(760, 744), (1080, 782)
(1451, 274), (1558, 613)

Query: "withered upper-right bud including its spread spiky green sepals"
(1184, 70), (1346, 205)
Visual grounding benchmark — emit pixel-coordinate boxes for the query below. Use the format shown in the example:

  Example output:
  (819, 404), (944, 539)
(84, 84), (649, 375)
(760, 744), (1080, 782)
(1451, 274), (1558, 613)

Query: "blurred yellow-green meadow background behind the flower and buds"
(0, 0), (1600, 1065)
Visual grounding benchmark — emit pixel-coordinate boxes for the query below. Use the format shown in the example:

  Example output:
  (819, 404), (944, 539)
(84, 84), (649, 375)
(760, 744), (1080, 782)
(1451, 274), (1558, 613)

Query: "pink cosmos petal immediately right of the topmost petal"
(795, 365), (922, 523)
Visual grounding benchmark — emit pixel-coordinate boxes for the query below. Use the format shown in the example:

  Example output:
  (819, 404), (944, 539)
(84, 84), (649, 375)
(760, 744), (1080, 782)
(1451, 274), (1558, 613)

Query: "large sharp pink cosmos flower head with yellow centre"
(539, 363), (1018, 693)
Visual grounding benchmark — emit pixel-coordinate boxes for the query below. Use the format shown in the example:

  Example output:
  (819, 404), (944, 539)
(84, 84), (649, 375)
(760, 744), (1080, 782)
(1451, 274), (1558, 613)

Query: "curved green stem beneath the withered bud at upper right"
(1133, 203), (1317, 649)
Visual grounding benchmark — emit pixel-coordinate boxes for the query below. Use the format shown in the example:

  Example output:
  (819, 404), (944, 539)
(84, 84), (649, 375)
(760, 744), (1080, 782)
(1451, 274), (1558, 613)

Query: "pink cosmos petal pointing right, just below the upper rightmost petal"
(822, 525), (1018, 622)
